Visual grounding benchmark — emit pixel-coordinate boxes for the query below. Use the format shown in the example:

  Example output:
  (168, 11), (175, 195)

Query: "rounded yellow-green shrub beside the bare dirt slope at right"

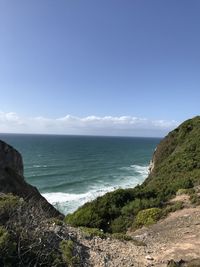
(134, 208), (162, 227)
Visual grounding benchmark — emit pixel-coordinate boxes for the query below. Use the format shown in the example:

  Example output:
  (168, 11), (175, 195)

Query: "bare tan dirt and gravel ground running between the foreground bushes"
(69, 198), (200, 267)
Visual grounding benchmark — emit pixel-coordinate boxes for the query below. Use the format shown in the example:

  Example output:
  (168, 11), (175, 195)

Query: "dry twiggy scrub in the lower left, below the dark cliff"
(0, 193), (85, 267)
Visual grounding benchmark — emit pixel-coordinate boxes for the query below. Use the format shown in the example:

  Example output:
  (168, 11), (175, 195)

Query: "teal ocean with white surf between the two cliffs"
(0, 134), (160, 214)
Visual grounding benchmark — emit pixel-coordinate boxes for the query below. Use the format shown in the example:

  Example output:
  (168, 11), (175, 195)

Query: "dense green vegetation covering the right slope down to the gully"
(65, 117), (200, 233)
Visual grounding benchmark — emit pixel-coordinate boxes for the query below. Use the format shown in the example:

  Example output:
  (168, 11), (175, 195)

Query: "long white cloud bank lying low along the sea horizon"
(0, 112), (178, 136)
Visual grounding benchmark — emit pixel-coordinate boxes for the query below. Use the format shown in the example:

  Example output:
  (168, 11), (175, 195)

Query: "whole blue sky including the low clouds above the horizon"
(0, 0), (200, 136)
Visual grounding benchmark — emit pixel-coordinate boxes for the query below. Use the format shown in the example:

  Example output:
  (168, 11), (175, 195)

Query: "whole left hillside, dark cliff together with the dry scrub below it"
(0, 141), (87, 267)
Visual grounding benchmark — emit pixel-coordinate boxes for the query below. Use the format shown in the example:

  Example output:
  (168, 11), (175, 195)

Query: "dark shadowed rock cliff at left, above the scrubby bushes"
(0, 141), (61, 217)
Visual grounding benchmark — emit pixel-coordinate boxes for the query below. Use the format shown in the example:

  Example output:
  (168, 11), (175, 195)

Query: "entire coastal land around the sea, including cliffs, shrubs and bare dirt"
(0, 117), (200, 267)
